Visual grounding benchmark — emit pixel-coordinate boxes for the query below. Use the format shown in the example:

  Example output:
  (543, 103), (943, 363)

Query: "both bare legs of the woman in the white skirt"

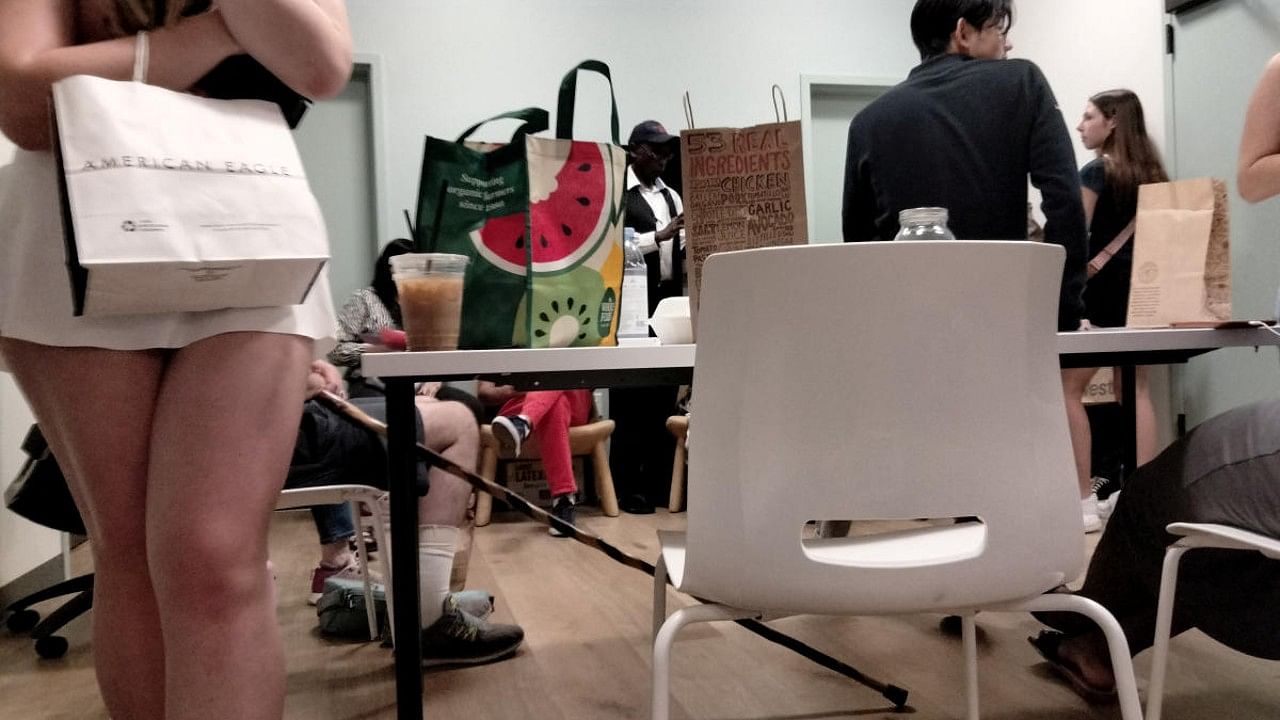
(0, 333), (311, 720)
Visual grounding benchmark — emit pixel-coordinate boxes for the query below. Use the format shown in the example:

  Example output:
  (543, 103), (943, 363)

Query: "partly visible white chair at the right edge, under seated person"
(1147, 523), (1280, 720)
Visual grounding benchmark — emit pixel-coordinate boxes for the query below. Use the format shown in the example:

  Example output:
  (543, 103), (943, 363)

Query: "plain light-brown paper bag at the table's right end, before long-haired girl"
(1125, 178), (1231, 327)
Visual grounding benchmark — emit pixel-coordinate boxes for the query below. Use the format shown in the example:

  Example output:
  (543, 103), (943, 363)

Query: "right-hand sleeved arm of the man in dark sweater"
(1010, 60), (1088, 331)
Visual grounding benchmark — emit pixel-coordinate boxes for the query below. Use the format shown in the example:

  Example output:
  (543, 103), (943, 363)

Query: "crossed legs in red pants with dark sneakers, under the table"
(493, 388), (591, 537)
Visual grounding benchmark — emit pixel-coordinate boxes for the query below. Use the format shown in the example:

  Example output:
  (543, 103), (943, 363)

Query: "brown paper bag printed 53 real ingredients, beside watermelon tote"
(680, 122), (809, 331)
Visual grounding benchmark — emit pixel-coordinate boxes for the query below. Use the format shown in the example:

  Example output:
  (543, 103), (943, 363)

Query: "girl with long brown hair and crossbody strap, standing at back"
(1062, 90), (1169, 529)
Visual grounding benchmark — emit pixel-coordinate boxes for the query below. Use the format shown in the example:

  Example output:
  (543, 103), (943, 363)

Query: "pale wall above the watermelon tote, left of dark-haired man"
(348, 0), (919, 232)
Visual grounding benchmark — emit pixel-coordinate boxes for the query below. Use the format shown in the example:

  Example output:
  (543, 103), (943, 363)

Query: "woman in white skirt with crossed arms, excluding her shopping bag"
(0, 0), (351, 720)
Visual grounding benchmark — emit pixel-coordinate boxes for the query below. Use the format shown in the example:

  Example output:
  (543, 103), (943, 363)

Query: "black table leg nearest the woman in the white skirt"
(387, 378), (424, 720)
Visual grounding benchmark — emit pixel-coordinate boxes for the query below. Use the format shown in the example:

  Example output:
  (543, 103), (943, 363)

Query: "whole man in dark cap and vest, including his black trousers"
(609, 120), (685, 512)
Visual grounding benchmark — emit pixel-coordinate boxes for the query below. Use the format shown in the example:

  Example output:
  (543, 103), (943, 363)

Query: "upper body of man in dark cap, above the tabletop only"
(625, 120), (685, 308)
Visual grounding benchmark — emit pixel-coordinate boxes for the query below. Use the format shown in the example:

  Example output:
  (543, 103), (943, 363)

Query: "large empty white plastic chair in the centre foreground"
(653, 241), (1142, 720)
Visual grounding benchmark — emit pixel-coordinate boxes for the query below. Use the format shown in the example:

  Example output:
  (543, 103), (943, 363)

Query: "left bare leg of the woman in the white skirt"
(0, 340), (164, 719)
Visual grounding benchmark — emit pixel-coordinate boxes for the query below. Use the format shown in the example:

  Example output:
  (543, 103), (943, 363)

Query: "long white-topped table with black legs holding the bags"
(361, 328), (1280, 720)
